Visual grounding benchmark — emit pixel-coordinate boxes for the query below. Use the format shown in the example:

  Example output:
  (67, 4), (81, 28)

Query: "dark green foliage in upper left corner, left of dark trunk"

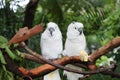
(0, 0), (24, 39)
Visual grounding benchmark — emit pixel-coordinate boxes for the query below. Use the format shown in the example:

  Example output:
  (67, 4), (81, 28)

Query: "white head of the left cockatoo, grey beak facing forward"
(45, 22), (61, 37)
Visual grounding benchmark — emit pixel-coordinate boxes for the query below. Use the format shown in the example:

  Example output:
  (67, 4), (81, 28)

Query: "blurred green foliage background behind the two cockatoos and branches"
(0, 0), (120, 80)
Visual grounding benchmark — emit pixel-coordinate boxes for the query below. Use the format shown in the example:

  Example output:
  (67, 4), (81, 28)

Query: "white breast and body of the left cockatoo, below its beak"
(41, 28), (63, 59)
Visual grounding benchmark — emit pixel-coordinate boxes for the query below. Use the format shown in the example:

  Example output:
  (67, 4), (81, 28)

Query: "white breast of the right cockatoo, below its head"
(65, 36), (86, 56)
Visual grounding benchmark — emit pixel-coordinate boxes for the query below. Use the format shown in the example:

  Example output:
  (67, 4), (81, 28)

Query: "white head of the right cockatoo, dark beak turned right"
(67, 22), (84, 38)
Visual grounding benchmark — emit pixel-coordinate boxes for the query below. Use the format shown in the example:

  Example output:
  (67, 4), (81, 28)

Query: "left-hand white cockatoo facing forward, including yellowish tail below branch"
(40, 22), (63, 80)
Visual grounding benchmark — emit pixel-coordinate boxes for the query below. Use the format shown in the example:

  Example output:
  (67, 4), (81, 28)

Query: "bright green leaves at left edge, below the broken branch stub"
(0, 36), (21, 80)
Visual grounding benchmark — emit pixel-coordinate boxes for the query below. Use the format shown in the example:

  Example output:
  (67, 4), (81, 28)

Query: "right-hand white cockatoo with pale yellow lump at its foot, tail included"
(63, 22), (88, 80)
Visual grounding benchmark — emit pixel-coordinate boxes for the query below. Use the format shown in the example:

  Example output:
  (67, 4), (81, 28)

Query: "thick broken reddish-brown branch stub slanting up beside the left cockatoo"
(8, 24), (43, 45)
